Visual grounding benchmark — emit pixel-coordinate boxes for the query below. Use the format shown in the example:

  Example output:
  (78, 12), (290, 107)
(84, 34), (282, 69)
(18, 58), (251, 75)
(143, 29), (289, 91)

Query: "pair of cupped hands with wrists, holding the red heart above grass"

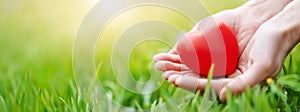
(153, 0), (300, 101)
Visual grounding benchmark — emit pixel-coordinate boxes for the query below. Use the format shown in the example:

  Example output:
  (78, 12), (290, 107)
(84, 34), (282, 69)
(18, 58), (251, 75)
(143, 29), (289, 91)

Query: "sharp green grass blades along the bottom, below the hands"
(0, 51), (300, 112)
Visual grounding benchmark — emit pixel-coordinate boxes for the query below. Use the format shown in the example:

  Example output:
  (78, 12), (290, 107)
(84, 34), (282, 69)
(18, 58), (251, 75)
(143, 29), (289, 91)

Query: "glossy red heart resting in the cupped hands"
(177, 17), (239, 76)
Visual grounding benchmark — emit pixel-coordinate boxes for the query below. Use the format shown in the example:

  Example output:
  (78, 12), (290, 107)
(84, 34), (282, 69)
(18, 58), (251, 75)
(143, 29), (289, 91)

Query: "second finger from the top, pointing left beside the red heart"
(155, 61), (188, 72)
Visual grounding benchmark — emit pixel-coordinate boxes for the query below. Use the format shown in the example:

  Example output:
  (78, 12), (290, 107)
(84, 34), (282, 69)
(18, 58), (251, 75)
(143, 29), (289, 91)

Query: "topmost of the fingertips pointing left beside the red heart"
(153, 53), (181, 63)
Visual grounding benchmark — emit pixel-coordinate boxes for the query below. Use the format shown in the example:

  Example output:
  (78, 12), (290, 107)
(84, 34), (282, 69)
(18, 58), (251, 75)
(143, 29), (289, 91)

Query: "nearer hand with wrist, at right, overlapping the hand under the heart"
(220, 0), (300, 101)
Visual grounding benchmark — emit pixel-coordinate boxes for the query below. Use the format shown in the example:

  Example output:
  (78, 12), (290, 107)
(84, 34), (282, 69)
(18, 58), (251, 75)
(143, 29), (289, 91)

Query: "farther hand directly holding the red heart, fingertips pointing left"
(153, 0), (290, 100)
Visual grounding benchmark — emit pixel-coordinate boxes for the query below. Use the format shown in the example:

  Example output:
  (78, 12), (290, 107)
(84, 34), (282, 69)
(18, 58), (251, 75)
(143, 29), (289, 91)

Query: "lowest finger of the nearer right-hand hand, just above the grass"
(219, 64), (272, 101)
